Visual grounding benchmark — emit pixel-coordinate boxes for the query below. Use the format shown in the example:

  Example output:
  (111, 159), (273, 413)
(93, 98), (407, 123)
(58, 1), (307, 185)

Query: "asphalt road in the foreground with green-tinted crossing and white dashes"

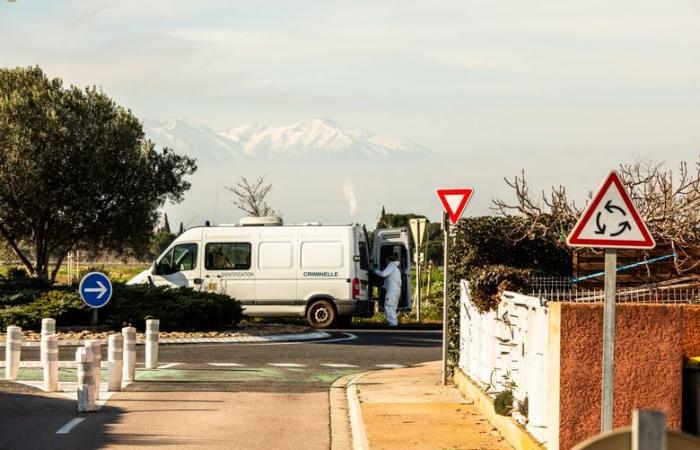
(0, 329), (441, 449)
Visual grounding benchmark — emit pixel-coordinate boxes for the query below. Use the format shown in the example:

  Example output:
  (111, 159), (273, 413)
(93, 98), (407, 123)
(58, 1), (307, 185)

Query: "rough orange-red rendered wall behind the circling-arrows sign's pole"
(559, 303), (688, 449)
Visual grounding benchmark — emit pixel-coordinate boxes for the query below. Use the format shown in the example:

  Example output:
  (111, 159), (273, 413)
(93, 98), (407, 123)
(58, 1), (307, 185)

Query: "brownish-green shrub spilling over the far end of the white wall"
(469, 264), (532, 312)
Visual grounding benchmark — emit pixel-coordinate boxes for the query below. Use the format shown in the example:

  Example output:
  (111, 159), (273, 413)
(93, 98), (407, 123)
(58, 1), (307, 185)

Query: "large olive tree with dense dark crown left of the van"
(0, 67), (196, 280)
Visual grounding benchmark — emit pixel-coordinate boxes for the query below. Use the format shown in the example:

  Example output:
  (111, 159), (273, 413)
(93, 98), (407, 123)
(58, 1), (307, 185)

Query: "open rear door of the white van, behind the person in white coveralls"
(372, 228), (411, 311)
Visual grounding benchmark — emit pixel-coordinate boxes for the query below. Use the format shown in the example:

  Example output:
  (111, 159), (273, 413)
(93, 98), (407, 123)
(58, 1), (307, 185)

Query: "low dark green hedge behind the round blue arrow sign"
(0, 280), (242, 331)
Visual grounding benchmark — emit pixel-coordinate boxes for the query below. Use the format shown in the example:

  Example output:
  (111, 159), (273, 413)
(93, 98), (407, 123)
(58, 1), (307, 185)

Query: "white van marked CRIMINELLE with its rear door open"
(129, 218), (411, 328)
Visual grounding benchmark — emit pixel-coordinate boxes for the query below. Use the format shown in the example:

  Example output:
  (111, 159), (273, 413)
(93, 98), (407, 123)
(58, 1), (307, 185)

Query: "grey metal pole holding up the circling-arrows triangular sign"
(600, 248), (617, 433)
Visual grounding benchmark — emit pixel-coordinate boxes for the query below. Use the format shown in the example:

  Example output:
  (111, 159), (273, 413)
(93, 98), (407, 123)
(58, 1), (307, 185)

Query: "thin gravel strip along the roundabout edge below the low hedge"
(0, 323), (314, 342)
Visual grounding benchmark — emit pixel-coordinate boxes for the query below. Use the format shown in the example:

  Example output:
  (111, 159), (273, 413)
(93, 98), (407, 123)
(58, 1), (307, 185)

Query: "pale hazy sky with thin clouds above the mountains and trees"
(0, 0), (700, 225)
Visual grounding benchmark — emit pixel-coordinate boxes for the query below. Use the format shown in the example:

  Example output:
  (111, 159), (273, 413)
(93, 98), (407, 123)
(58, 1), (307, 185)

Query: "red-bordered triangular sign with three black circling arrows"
(566, 170), (656, 249)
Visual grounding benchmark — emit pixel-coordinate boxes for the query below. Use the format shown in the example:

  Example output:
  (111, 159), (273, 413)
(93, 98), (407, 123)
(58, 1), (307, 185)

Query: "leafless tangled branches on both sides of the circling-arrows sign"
(492, 156), (700, 273)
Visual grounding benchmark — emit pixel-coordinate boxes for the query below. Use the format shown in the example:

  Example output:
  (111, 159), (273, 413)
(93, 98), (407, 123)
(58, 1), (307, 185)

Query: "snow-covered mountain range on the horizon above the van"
(144, 119), (427, 162)
